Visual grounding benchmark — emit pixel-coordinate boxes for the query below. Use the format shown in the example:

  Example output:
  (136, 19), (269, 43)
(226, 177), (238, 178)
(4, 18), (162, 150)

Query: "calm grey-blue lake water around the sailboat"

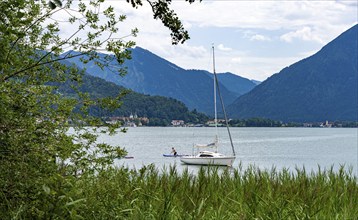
(99, 127), (358, 175)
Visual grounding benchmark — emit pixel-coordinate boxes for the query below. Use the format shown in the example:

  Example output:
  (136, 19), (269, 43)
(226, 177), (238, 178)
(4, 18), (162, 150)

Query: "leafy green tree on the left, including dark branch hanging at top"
(0, 0), (199, 219)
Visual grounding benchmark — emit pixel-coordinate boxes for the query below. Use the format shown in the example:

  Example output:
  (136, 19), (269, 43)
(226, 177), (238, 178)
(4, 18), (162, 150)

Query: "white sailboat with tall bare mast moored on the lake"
(180, 46), (236, 166)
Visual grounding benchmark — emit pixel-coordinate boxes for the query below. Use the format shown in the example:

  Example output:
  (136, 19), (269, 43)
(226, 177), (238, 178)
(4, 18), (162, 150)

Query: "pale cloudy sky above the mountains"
(58, 0), (358, 81)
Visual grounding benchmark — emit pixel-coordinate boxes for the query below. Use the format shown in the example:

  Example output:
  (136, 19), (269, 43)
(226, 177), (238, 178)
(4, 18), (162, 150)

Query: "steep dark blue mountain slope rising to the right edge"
(227, 25), (358, 122)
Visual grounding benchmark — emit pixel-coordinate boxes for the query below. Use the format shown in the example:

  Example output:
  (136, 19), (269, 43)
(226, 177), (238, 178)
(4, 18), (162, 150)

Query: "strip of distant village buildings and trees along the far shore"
(106, 114), (358, 128)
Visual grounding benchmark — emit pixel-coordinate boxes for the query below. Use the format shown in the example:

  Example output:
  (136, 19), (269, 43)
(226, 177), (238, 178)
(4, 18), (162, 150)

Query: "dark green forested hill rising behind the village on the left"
(57, 71), (208, 126)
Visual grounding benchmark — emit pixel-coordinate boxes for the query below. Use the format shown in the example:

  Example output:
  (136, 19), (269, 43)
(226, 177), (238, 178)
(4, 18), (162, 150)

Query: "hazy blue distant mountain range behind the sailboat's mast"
(62, 47), (255, 114)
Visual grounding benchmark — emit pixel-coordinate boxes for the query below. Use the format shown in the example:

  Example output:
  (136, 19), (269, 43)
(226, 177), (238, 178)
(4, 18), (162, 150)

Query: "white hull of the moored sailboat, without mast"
(180, 156), (235, 166)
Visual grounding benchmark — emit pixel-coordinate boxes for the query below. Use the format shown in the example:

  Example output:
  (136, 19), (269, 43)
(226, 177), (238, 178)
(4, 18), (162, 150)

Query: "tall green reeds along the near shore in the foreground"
(72, 166), (358, 219)
